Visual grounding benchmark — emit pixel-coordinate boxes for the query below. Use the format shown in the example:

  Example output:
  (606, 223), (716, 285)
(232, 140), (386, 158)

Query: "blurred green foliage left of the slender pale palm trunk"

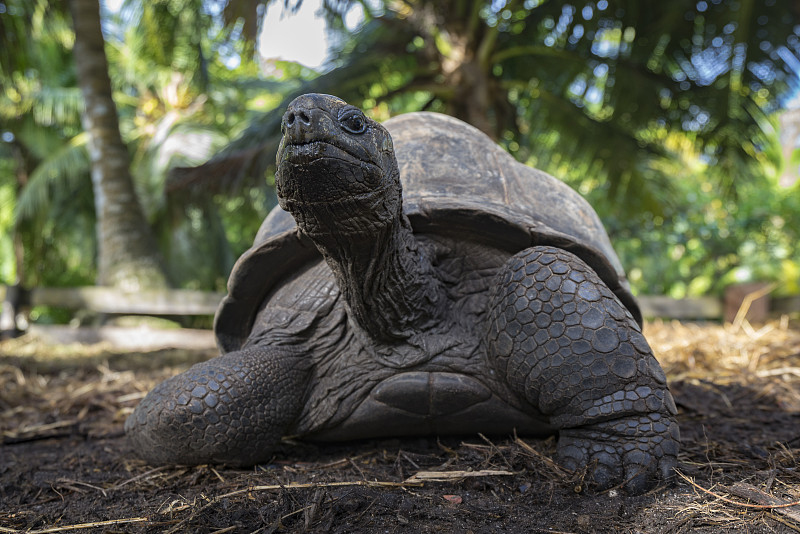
(0, 0), (94, 285)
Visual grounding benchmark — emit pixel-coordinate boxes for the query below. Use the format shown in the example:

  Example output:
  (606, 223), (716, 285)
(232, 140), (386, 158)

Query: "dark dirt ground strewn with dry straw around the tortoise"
(0, 318), (800, 534)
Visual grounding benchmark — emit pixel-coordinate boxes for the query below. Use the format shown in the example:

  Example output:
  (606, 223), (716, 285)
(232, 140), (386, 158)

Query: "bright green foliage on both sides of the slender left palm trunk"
(0, 0), (288, 289)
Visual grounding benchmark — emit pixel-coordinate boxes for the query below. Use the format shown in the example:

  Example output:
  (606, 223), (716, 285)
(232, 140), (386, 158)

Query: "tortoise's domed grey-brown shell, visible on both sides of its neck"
(214, 112), (642, 353)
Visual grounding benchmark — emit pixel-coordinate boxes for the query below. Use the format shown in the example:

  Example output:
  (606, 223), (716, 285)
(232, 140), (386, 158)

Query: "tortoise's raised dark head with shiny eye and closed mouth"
(275, 94), (402, 238)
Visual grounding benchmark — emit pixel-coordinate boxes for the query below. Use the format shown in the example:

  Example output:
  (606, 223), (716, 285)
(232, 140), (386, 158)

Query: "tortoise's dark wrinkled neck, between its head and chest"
(314, 215), (444, 341)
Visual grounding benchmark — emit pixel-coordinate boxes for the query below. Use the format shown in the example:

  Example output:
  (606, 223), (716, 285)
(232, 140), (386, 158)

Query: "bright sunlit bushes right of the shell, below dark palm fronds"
(589, 155), (800, 298)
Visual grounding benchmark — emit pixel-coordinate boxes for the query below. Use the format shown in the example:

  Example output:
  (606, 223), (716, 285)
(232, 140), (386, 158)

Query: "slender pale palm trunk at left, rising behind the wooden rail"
(70, 0), (167, 291)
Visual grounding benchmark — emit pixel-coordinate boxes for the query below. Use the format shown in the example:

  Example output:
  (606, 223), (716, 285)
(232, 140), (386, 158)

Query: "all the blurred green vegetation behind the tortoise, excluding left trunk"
(0, 0), (800, 322)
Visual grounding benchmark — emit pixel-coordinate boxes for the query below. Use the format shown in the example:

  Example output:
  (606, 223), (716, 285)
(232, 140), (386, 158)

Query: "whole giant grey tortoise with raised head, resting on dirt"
(125, 94), (679, 492)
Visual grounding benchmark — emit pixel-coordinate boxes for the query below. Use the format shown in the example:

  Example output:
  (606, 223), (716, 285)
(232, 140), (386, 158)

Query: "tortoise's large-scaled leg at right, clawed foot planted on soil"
(487, 247), (679, 493)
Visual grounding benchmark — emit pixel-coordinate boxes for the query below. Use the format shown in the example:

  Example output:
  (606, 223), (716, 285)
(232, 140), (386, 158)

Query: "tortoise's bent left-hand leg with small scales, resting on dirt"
(125, 346), (310, 465)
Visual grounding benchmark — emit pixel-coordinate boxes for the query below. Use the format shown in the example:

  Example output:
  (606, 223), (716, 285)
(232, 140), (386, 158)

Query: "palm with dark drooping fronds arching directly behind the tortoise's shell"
(175, 0), (800, 216)
